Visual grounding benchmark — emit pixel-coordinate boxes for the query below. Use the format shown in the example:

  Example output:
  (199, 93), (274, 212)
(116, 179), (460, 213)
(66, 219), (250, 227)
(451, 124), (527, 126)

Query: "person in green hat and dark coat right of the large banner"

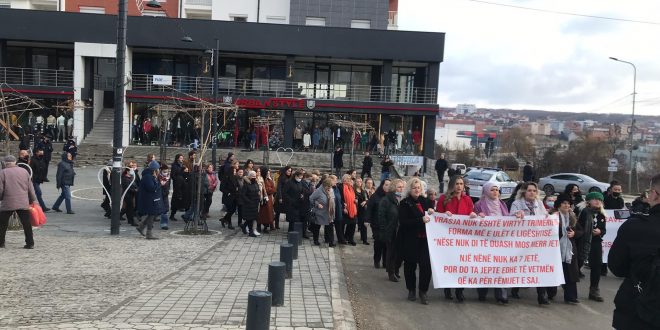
(578, 191), (607, 302)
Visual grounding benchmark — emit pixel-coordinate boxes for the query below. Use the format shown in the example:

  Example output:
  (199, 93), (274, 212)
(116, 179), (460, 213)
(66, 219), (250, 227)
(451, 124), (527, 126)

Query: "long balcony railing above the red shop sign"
(132, 74), (438, 104)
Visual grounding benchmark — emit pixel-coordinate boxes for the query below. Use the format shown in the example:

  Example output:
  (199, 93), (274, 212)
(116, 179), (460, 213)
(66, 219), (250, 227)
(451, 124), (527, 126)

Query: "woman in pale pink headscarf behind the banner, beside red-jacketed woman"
(474, 182), (509, 304)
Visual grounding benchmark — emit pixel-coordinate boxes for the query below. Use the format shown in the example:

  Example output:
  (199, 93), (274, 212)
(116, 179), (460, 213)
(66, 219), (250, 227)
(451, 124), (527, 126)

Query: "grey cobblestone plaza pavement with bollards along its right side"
(0, 169), (354, 329)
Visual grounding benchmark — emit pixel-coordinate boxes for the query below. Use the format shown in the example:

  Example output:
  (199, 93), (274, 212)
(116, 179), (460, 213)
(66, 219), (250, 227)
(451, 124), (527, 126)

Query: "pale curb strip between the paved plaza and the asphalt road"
(329, 246), (357, 330)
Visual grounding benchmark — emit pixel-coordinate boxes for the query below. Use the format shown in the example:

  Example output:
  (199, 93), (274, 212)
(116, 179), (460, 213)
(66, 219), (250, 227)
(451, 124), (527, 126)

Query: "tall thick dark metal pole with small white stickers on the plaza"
(110, 0), (128, 235)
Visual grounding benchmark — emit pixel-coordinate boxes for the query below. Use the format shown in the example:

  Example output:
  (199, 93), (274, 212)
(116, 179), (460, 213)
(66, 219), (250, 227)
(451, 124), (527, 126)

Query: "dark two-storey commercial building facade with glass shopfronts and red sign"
(0, 9), (444, 157)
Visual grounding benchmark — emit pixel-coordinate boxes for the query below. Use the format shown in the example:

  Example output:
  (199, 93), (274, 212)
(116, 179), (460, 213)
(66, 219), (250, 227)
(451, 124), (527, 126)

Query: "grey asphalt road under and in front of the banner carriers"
(341, 244), (621, 330)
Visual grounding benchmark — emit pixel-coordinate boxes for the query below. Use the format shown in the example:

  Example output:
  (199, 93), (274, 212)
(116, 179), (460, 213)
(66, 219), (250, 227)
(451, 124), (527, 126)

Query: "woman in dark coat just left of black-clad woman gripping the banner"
(378, 179), (406, 282)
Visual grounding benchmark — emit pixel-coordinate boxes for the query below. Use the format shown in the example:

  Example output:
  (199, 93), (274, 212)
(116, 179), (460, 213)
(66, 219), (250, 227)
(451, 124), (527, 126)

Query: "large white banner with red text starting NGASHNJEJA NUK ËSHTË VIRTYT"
(426, 213), (564, 289)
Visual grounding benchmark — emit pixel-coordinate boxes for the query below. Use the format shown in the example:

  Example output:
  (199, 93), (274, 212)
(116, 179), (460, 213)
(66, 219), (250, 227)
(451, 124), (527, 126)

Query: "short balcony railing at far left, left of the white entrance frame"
(0, 67), (73, 87)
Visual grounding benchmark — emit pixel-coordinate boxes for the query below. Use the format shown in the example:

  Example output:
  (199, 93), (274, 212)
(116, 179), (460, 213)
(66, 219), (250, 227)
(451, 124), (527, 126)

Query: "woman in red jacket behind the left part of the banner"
(435, 175), (477, 303)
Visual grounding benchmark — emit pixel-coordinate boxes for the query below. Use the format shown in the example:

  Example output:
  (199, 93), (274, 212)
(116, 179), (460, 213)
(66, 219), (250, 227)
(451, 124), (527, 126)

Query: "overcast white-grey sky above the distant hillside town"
(399, 0), (660, 115)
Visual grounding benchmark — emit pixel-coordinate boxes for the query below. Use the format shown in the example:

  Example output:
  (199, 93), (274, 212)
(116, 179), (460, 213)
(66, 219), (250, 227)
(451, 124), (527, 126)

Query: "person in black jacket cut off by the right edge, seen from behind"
(607, 174), (660, 330)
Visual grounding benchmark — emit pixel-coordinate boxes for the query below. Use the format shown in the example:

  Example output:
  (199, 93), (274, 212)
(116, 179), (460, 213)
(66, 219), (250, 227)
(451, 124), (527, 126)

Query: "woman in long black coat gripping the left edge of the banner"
(397, 178), (438, 305)
